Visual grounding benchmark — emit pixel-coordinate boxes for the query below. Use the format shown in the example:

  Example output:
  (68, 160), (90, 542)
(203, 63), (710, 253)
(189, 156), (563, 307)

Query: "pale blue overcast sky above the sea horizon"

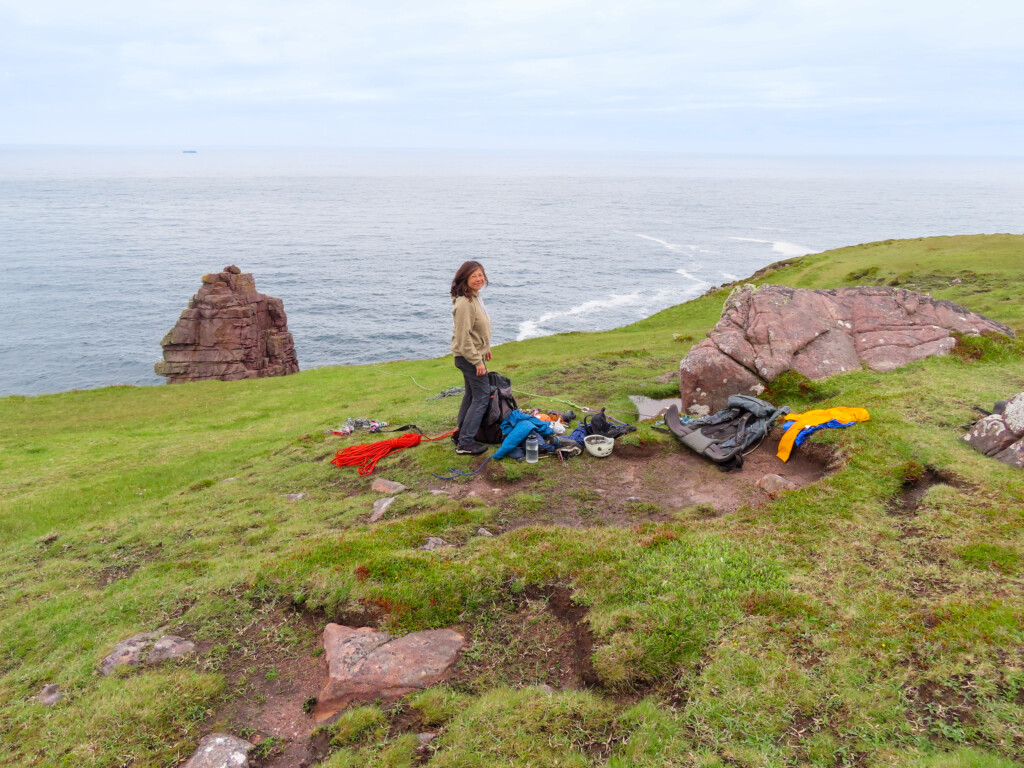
(0, 0), (1024, 155)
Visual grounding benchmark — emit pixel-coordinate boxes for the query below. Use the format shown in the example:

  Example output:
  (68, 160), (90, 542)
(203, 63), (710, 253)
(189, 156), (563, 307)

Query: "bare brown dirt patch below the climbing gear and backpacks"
(433, 430), (831, 530)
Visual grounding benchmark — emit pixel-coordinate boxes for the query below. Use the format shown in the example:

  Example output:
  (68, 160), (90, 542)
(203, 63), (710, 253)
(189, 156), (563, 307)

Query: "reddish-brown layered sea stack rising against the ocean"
(156, 266), (299, 384)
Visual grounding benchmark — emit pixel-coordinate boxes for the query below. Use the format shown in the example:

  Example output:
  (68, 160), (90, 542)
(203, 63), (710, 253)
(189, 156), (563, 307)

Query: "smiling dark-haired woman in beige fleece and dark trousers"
(452, 261), (490, 456)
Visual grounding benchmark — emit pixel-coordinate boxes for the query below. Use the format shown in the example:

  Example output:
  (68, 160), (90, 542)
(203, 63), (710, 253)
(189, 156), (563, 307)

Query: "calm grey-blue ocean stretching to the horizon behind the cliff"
(0, 147), (1024, 395)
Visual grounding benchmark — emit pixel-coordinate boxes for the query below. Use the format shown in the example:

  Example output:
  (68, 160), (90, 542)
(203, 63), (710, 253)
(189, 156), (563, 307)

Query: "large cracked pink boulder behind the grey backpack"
(679, 285), (1013, 416)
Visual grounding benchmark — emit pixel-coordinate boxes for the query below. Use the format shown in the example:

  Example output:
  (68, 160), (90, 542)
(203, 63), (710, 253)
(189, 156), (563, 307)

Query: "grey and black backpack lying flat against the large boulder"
(665, 394), (790, 471)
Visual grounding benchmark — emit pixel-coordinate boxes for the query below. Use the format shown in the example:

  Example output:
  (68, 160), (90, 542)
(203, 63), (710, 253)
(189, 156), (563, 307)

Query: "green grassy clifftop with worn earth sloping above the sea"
(0, 236), (1024, 766)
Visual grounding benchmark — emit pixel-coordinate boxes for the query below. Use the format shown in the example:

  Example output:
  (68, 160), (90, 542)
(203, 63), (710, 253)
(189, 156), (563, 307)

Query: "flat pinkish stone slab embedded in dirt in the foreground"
(314, 624), (466, 722)
